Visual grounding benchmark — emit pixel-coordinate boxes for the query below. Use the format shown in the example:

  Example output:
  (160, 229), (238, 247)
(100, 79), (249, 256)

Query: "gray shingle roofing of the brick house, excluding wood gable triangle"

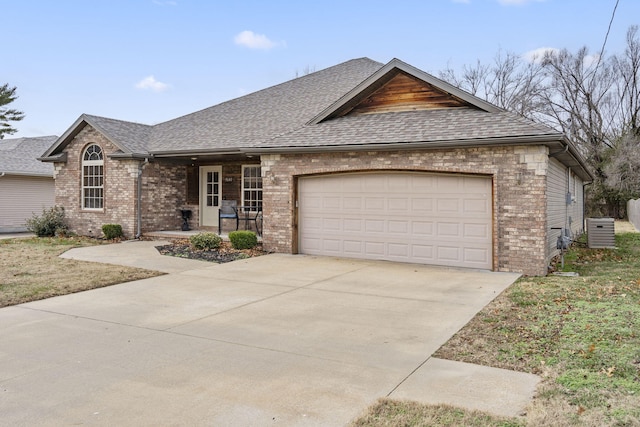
(45, 58), (559, 159)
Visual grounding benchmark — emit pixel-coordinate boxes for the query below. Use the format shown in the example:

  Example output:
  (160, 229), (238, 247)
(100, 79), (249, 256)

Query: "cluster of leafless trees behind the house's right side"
(440, 26), (640, 216)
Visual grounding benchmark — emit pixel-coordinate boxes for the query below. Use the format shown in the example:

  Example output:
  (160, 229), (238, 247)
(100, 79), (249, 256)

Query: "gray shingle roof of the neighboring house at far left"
(0, 135), (58, 178)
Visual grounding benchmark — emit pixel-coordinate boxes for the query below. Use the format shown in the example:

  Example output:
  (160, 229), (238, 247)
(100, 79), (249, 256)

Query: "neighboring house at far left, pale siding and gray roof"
(0, 136), (58, 233)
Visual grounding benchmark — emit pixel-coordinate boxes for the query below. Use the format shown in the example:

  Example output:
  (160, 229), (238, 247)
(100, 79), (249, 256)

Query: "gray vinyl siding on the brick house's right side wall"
(547, 159), (584, 260)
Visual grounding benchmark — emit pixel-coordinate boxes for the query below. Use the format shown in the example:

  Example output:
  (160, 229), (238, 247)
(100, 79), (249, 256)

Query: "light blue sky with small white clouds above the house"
(5, 0), (640, 138)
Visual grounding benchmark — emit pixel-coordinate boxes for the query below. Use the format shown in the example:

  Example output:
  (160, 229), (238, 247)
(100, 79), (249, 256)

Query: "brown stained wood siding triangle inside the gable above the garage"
(341, 70), (472, 116)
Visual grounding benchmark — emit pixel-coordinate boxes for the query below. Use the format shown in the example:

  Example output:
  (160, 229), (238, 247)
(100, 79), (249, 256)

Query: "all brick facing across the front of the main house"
(55, 126), (549, 275)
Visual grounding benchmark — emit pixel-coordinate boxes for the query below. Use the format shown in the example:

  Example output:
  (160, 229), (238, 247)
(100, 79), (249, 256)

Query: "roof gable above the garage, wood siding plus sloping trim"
(308, 59), (504, 124)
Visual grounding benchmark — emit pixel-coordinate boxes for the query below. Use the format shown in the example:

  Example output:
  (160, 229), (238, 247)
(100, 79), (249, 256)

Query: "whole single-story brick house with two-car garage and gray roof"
(41, 58), (591, 275)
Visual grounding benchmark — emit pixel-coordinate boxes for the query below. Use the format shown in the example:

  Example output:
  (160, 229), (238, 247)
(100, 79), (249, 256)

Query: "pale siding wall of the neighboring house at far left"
(0, 175), (55, 233)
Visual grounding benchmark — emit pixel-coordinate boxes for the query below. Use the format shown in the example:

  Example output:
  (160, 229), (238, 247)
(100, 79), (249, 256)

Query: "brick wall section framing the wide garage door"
(261, 145), (548, 275)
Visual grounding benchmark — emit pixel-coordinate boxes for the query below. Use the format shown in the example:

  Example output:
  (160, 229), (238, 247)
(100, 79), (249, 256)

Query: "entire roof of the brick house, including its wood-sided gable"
(42, 58), (590, 180)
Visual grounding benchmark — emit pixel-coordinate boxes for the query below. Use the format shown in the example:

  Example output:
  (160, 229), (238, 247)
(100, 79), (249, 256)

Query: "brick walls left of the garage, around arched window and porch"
(54, 130), (259, 238)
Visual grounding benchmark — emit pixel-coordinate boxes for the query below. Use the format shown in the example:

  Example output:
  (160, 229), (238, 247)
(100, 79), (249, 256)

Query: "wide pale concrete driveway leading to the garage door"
(0, 249), (537, 426)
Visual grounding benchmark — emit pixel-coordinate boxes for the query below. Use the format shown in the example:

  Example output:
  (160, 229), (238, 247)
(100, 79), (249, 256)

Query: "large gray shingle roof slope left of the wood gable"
(148, 58), (383, 152)
